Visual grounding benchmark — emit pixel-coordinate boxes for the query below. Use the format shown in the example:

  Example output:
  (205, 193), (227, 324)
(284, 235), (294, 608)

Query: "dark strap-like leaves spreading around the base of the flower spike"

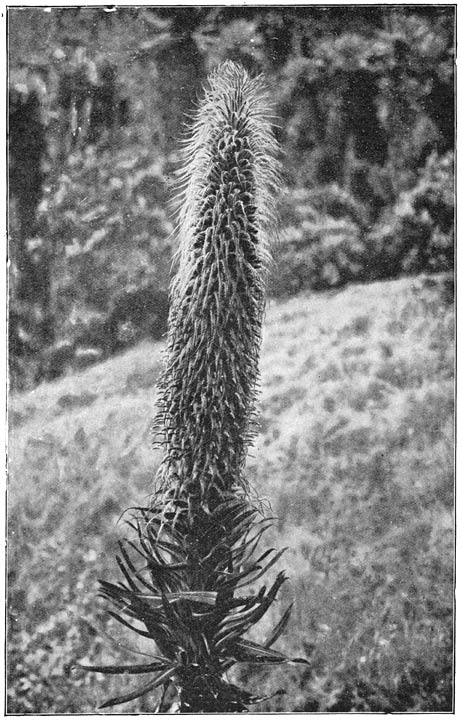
(77, 494), (306, 713)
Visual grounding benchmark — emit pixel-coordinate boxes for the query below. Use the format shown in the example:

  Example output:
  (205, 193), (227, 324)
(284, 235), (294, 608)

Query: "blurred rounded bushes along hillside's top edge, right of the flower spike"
(270, 154), (454, 296)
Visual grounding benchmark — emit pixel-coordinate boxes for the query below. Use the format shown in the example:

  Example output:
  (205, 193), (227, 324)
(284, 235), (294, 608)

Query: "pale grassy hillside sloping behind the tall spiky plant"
(8, 276), (454, 714)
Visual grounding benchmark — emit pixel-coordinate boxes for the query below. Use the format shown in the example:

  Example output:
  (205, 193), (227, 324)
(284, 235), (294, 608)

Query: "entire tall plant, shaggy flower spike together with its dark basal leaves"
(76, 62), (305, 713)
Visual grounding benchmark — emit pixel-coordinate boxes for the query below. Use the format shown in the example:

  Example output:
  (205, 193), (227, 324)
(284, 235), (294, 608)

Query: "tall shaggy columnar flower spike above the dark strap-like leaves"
(156, 62), (278, 501)
